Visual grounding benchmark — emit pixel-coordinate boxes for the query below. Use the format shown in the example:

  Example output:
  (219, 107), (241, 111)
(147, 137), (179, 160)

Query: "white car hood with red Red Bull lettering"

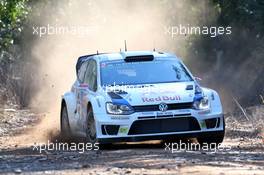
(107, 82), (195, 106)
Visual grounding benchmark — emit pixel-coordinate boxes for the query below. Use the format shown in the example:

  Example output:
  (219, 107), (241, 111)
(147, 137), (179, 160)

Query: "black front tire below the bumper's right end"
(196, 118), (225, 145)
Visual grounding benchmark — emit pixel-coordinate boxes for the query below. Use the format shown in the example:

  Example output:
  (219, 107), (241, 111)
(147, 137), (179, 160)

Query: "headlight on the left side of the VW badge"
(106, 102), (134, 115)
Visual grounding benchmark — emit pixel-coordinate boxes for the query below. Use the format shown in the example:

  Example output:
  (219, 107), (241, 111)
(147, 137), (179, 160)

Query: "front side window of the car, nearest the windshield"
(84, 60), (97, 91)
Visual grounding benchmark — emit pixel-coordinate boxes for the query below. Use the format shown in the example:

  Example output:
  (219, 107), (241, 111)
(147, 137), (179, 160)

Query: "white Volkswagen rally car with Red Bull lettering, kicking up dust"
(61, 51), (225, 143)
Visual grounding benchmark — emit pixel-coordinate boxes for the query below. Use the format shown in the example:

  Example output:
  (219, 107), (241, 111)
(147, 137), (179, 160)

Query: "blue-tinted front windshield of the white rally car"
(100, 60), (192, 86)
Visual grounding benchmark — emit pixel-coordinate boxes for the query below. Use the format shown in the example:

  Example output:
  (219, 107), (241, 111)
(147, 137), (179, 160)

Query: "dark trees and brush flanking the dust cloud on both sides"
(0, 0), (264, 107)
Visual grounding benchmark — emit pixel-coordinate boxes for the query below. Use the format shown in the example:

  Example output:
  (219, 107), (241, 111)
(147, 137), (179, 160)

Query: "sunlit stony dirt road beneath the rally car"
(0, 107), (264, 174)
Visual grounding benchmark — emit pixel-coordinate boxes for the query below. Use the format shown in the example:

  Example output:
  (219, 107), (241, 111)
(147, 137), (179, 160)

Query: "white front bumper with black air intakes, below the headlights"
(96, 109), (224, 143)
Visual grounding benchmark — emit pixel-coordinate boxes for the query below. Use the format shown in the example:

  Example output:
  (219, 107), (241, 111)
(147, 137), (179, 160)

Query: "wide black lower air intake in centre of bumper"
(128, 117), (200, 135)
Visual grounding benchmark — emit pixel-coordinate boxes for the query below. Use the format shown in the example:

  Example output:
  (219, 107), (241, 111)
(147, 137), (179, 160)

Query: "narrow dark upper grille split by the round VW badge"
(133, 103), (193, 112)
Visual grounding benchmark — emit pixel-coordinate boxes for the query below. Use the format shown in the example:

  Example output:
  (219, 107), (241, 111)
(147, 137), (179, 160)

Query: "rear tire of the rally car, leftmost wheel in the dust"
(60, 104), (71, 140)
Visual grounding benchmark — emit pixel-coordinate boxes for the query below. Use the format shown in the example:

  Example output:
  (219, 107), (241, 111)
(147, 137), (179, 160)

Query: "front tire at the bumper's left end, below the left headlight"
(86, 107), (97, 144)
